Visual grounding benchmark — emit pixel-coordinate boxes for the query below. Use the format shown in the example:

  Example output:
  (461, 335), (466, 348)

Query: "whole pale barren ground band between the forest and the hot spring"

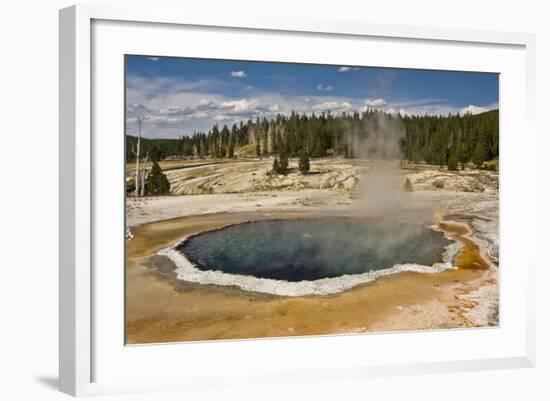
(126, 158), (498, 238)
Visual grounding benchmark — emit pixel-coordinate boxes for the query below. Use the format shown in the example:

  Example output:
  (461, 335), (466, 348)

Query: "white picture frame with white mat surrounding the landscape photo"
(59, 5), (537, 396)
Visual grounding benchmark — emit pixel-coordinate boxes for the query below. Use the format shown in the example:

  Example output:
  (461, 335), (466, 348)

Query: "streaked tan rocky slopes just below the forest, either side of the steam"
(156, 158), (498, 195)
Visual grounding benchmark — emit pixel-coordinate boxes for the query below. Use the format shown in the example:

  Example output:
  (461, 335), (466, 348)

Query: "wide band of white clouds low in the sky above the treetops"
(126, 76), (498, 138)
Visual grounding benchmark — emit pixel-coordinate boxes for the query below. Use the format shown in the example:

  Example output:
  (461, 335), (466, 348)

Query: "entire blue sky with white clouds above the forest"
(126, 56), (498, 138)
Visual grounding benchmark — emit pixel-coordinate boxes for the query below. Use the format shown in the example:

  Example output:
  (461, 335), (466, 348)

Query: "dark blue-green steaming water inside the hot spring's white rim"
(175, 218), (451, 282)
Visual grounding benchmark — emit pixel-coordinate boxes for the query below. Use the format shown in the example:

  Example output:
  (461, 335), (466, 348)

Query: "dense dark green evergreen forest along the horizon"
(126, 110), (499, 169)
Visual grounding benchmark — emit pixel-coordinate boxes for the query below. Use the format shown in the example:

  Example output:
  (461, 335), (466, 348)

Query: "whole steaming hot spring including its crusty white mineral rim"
(161, 217), (457, 296)
